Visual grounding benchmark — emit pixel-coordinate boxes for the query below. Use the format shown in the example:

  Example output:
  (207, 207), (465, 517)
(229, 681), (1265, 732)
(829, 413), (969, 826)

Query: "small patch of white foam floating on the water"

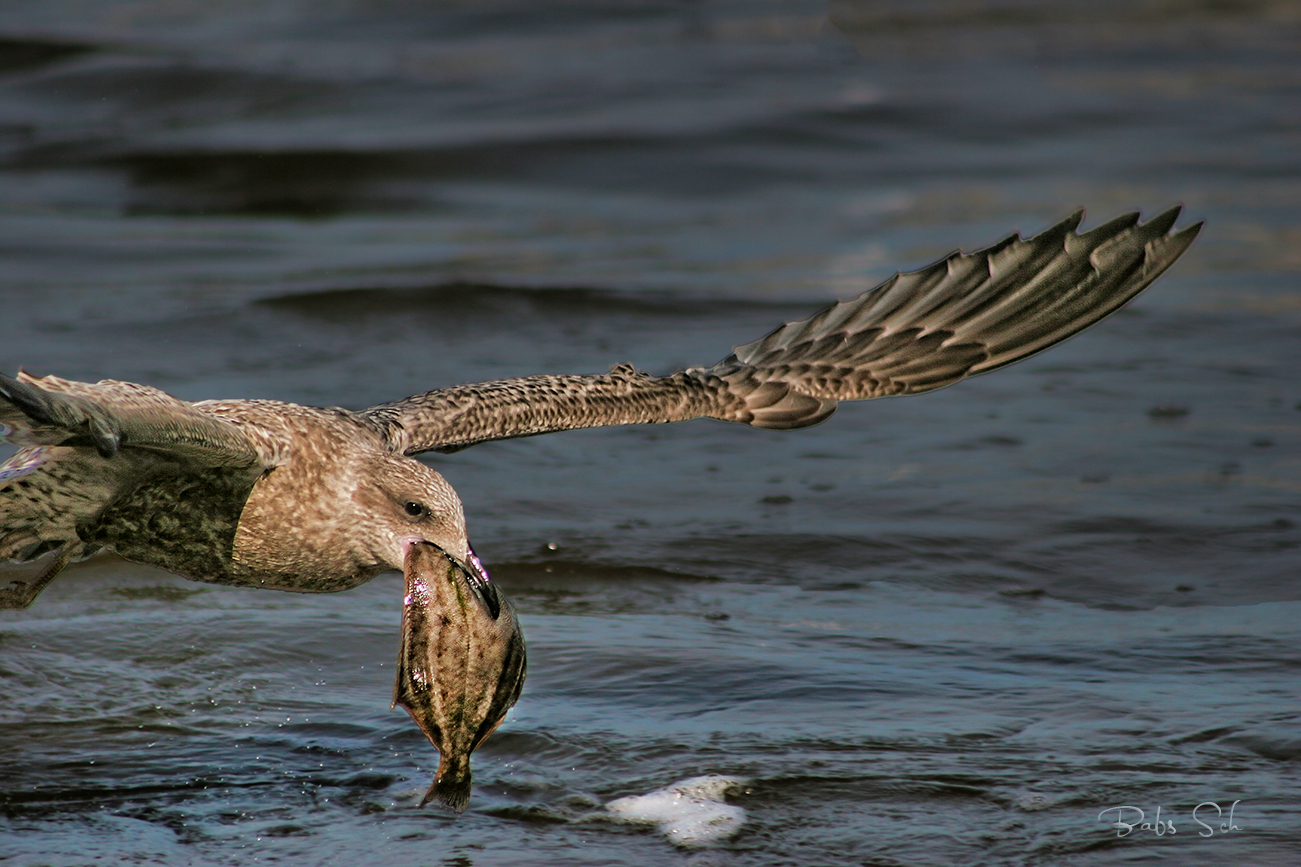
(605, 773), (745, 849)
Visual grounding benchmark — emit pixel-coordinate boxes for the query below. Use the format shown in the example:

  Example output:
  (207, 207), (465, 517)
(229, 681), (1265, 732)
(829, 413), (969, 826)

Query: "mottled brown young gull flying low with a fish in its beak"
(0, 207), (1202, 608)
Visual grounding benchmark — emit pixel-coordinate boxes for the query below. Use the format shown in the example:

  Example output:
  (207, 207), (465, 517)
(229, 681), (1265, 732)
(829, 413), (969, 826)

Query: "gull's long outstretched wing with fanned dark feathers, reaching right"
(364, 207), (1202, 454)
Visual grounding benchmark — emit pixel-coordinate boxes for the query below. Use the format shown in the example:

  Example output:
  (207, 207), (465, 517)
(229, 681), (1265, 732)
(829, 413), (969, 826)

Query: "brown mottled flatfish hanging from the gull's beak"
(393, 542), (526, 812)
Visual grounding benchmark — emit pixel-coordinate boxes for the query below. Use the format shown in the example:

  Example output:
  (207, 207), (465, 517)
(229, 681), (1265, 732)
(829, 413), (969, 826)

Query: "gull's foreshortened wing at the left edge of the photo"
(0, 372), (276, 467)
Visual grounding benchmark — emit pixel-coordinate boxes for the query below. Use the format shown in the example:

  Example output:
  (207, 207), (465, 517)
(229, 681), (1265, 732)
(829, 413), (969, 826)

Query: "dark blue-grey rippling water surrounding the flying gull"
(0, 0), (1301, 867)
